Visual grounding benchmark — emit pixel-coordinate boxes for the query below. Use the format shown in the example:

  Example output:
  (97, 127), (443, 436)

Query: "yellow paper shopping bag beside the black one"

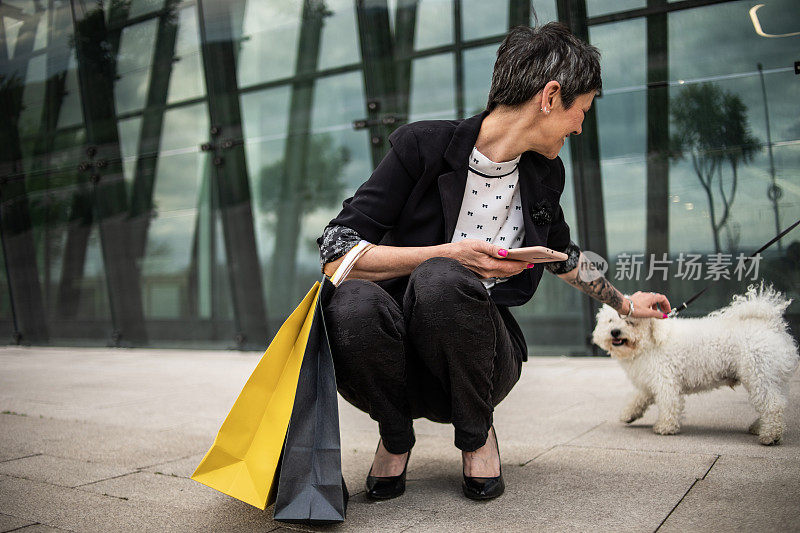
(191, 282), (320, 509)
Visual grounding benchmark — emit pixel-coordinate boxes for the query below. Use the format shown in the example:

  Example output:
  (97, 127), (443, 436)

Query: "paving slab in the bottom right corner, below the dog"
(659, 456), (800, 532)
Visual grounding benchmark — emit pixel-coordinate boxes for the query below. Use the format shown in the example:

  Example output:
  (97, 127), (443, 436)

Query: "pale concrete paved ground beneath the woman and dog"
(0, 347), (800, 533)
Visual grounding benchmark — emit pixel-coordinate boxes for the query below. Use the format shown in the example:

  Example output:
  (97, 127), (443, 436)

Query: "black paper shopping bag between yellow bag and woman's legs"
(274, 278), (348, 525)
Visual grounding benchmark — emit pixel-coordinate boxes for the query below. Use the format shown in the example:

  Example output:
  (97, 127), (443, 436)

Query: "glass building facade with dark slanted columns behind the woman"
(0, 0), (800, 355)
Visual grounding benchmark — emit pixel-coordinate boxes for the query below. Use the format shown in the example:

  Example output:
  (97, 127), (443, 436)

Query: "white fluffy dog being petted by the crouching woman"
(592, 282), (800, 445)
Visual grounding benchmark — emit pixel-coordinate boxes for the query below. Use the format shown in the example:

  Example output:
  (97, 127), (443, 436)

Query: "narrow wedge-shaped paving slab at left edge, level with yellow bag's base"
(0, 455), (130, 487)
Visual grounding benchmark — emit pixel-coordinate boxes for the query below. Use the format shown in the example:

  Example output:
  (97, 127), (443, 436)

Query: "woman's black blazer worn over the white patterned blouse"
(322, 111), (570, 306)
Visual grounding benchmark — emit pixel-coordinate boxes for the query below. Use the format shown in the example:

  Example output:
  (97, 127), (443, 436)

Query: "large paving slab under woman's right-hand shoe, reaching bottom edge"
(378, 447), (715, 531)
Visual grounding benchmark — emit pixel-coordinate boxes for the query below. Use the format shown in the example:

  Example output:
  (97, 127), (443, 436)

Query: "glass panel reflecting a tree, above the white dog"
(669, 0), (800, 314)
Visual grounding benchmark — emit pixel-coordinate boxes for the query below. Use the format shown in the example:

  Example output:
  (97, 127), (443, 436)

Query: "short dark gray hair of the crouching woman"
(486, 22), (602, 111)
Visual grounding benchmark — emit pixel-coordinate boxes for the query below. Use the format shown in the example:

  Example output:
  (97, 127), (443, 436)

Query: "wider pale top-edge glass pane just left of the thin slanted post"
(237, 0), (303, 87)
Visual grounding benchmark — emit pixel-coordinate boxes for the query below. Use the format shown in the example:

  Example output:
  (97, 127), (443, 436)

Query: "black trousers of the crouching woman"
(325, 257), (526, 453)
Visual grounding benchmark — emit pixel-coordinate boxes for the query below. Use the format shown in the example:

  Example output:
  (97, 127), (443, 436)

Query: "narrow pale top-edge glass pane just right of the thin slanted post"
(318, 0), (360, 70)
